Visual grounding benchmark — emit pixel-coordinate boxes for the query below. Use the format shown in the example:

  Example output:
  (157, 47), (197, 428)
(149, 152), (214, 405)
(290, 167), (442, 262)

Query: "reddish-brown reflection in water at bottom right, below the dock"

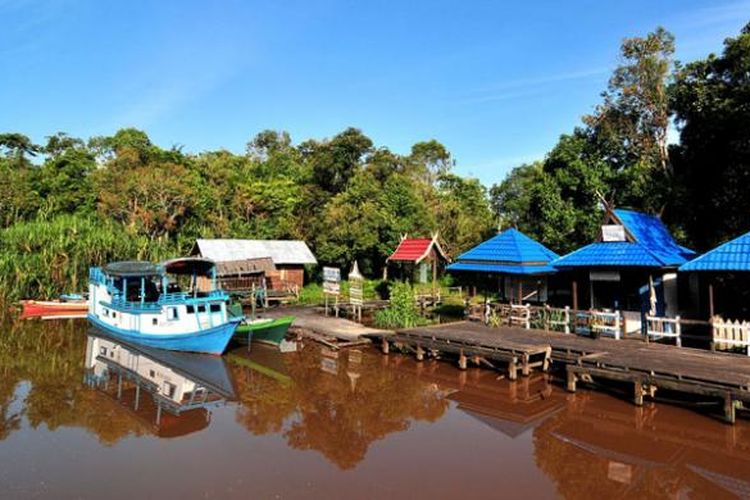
(534, 394), (750, 498)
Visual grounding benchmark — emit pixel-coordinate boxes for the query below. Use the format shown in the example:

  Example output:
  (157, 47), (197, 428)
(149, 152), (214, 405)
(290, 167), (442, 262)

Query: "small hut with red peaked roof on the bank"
(386, 234), (450, 284)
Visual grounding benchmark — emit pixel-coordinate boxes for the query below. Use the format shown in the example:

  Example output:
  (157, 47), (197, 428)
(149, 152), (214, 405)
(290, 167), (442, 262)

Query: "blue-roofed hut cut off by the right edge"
(679, 233), (750, 318)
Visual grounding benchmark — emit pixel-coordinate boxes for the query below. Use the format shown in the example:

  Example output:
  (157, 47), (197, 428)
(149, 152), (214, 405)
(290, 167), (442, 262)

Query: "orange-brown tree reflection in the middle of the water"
(234, 346), (448, 469)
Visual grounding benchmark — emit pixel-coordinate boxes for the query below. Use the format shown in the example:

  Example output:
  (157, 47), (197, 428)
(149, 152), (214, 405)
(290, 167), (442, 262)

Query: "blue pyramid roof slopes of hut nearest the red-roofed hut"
(456, 229), (560, 264)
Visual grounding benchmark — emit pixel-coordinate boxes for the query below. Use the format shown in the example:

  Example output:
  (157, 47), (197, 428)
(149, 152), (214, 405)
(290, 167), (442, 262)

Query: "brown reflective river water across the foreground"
(0, 321), (750, 499)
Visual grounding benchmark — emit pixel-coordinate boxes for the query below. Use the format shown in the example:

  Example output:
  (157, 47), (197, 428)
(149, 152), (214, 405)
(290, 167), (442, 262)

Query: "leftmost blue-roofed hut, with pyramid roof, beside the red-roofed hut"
(447, 229), (559, 303)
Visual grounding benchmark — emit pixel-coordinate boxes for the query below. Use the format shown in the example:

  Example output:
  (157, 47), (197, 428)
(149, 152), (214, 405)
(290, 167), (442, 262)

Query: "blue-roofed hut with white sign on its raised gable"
(553, 206), (695, 324)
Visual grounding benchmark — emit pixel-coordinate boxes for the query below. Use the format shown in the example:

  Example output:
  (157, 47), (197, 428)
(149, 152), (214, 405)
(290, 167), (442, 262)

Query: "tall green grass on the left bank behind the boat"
(0, 215), (174, 303)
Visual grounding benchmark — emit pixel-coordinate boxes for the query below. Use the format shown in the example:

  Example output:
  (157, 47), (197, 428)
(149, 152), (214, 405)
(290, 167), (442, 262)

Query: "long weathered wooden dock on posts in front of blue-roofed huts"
(380, 321), (750, 423)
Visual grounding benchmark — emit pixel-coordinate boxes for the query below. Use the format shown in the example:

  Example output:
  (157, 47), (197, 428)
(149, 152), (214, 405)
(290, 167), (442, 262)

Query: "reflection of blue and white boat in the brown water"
(84, 328), (235, 437)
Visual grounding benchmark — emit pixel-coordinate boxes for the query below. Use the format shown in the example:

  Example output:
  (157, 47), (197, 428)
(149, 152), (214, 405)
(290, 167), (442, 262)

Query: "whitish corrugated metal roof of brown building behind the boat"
(195, 239), (318, 266)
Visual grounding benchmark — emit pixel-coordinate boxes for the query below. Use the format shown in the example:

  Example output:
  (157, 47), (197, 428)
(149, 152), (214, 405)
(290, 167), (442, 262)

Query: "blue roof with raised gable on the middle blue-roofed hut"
(553, 209), (695, 267)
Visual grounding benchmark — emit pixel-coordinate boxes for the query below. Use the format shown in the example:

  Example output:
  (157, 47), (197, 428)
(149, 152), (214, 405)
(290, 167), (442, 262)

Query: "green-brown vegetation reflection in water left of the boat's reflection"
(0, 321), (151, 444)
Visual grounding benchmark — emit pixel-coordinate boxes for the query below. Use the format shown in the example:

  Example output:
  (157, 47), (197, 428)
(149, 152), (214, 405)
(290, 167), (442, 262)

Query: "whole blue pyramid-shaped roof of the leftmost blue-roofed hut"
(448, 229), (559, 274)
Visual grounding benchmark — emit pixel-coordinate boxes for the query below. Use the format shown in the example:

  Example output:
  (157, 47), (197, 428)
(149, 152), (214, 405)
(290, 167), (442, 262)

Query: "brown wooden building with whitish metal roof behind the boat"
(192, 239), (318, 290)
